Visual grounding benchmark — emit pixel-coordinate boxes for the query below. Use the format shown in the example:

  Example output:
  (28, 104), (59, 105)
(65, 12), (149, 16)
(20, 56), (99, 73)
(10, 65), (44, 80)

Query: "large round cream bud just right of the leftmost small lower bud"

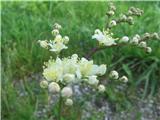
(48, 82), (60, 93)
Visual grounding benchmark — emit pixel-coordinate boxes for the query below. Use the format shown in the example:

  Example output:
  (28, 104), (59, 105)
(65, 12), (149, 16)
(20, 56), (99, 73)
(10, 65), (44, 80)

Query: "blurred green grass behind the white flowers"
(1, 1), (160, 120)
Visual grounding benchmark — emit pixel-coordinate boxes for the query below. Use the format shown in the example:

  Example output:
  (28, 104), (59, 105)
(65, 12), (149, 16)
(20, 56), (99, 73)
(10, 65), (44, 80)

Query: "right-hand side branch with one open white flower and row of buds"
(92, 29), (159, 53)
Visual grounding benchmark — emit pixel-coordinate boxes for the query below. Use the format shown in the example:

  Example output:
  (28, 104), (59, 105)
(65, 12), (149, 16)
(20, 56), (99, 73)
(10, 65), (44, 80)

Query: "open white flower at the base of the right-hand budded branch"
(92, 29), (116, 46)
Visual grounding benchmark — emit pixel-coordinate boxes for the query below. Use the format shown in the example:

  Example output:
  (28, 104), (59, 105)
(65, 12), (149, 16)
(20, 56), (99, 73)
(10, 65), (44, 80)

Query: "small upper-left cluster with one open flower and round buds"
(38, 23), (69, 53)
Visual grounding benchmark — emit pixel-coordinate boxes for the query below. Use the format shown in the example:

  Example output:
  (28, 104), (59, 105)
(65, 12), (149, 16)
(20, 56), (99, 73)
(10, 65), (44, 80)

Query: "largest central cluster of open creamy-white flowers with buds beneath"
(40, 54), (106, 105)
